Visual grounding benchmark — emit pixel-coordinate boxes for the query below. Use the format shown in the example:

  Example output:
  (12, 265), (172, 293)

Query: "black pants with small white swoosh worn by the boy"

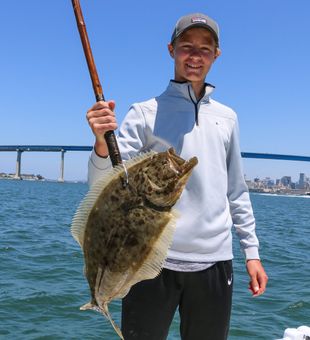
(122, 261), (233, 340)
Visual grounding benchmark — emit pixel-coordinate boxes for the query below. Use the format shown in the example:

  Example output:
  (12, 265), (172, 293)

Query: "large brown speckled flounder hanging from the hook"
(71, 149), (198, 339)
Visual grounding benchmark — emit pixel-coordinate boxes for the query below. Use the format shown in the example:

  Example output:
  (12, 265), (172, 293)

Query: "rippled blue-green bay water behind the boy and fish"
(0, 180), (310, 340)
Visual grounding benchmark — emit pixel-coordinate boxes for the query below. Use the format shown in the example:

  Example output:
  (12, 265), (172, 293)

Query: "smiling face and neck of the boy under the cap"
(168, 27), (220, 85)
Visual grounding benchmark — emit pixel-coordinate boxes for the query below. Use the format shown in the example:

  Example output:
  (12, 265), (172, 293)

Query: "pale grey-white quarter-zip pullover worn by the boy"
(89, 81), (259, 263)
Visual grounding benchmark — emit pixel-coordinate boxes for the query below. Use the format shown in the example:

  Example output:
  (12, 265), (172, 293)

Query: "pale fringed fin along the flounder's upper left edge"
(71, 151), (156, 249)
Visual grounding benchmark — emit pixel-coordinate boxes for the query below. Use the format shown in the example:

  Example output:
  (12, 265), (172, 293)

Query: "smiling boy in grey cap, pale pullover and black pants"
(87, 13), (268, 340)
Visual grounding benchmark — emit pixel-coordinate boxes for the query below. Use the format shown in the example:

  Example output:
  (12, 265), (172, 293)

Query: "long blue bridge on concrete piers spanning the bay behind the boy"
(0, 145), (310, 182)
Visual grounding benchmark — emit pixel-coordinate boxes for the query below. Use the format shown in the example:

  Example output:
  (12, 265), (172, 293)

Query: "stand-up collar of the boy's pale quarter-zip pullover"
(167, 80), (215, 104)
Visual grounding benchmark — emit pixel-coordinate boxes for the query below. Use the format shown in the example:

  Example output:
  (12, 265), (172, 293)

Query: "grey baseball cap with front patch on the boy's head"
(171, 13), (219, 45)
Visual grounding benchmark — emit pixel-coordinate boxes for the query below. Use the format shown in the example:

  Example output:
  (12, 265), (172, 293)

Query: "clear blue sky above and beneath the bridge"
(0, 0), (310, 180)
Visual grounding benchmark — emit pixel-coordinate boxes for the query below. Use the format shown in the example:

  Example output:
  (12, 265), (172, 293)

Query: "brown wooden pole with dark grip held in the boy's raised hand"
(72, 0), (126, 168)
